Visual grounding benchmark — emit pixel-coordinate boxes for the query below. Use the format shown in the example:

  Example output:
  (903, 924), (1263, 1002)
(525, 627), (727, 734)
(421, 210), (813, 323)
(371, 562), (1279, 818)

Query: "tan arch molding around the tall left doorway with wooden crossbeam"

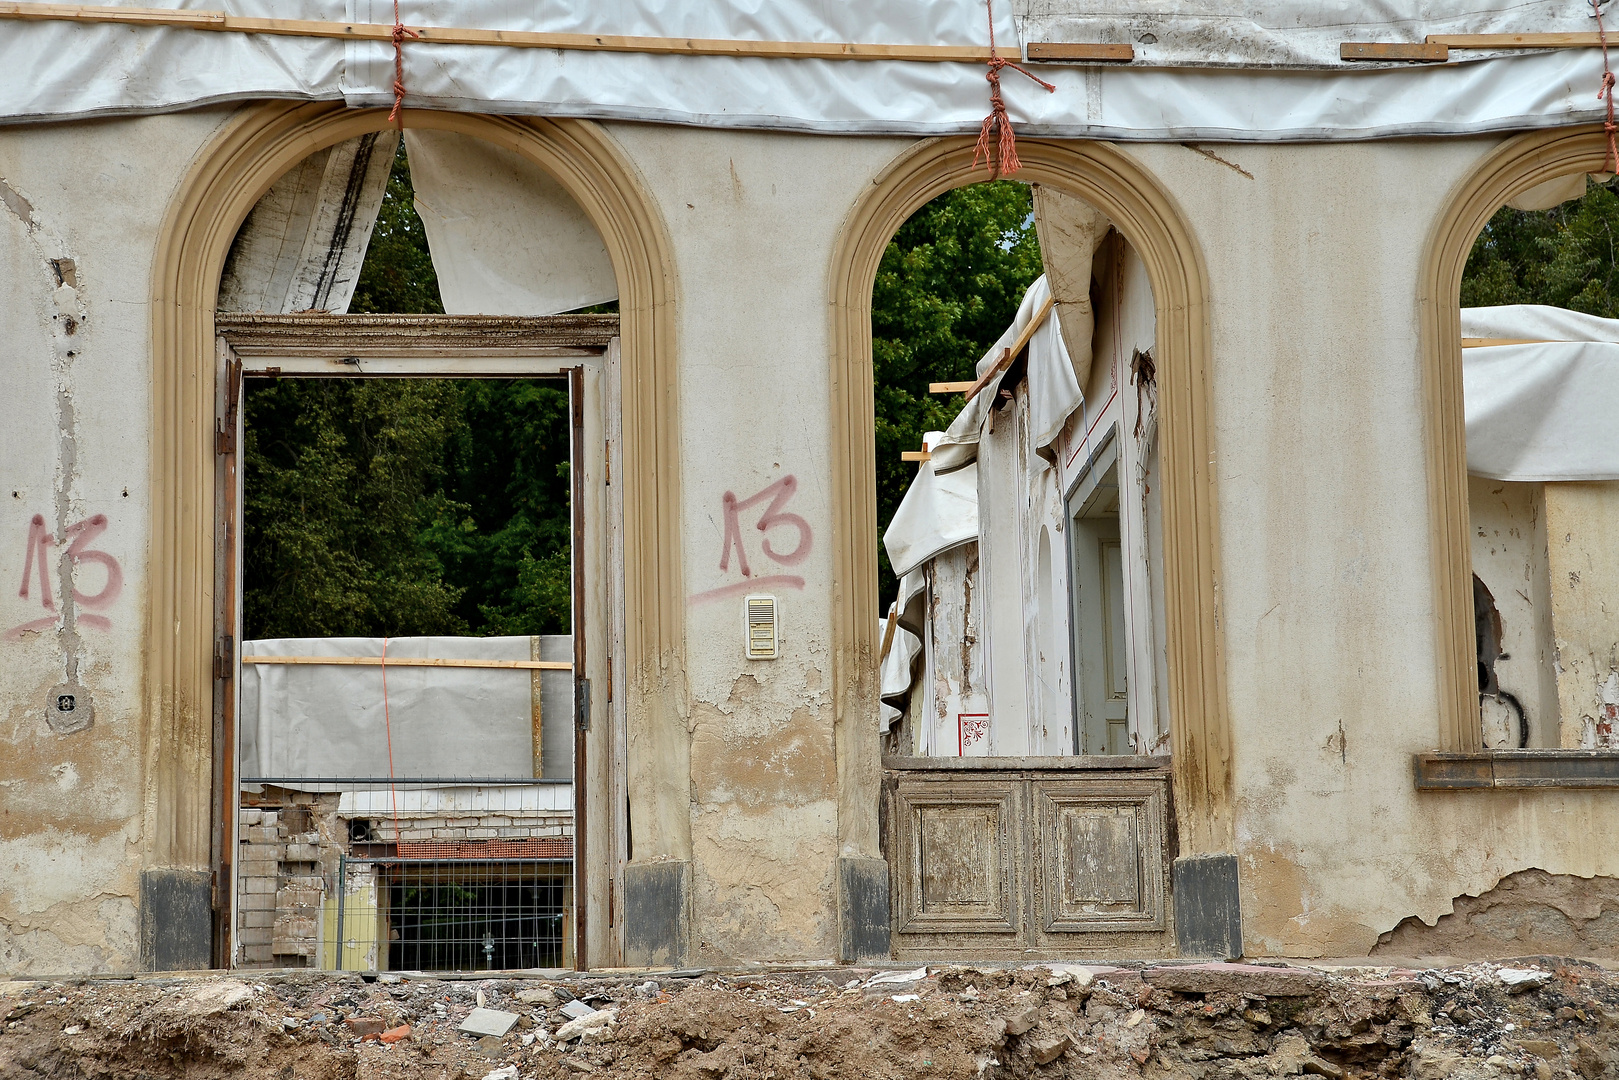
(142, 102), (690, 932)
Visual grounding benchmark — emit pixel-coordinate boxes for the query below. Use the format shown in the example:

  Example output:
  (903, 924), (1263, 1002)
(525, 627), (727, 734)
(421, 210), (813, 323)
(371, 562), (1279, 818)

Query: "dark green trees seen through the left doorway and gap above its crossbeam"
(243, 138), (572, 638)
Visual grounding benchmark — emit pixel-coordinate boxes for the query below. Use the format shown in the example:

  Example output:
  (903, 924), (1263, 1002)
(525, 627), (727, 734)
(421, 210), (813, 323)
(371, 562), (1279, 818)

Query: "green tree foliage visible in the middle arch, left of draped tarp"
(871, 180), (1041, 602)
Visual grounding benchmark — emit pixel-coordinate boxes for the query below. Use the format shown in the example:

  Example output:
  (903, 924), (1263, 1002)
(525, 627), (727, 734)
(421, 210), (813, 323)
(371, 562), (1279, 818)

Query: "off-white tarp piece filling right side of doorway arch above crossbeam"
(405, 131), (618, 316)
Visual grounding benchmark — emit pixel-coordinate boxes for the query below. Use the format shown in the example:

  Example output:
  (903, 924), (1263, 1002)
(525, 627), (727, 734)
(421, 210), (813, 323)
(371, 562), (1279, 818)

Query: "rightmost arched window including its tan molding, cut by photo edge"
(1418, 130), (1619, 761)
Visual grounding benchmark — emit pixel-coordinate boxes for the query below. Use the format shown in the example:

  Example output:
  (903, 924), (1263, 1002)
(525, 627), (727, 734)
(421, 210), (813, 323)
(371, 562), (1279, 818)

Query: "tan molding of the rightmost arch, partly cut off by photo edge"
(1417, 125), (1608, 753)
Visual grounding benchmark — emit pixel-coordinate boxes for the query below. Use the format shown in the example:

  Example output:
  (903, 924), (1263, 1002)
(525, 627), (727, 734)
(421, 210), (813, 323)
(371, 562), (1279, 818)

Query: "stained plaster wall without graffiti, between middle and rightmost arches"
(1128, 139), (1619, 955)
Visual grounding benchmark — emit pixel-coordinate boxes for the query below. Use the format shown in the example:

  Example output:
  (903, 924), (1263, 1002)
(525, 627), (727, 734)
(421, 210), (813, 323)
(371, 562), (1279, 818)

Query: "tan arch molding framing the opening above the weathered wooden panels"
(831, 138), (1234, 857)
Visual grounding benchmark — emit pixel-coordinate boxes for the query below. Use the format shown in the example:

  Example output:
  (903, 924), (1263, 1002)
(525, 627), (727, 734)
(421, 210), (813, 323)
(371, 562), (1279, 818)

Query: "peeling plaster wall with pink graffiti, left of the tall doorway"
(0, 110), (234, 973)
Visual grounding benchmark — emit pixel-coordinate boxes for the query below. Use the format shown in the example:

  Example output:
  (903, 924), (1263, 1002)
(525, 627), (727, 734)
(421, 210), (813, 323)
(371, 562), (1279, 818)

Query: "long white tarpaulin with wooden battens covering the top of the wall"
(0, 0), (1603, 141)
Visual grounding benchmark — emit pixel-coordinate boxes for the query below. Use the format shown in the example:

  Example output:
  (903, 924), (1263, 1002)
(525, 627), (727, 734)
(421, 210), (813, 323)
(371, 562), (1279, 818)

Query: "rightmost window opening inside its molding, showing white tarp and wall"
(1460, 172), (1619, 750)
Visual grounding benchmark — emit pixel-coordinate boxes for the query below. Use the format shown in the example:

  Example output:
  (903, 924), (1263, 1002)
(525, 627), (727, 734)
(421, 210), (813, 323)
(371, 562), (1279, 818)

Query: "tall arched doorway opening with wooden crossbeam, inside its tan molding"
(215, 130), (623, 970)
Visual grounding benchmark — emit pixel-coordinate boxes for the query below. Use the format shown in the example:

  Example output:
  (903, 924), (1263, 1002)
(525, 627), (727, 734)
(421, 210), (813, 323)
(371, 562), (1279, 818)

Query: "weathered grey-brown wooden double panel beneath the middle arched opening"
(884, 758), (1174, 960)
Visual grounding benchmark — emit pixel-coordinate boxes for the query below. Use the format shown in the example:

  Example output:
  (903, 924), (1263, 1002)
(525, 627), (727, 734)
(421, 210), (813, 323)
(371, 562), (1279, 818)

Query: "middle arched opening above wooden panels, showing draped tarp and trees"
(873, 181), (1169, 758)
